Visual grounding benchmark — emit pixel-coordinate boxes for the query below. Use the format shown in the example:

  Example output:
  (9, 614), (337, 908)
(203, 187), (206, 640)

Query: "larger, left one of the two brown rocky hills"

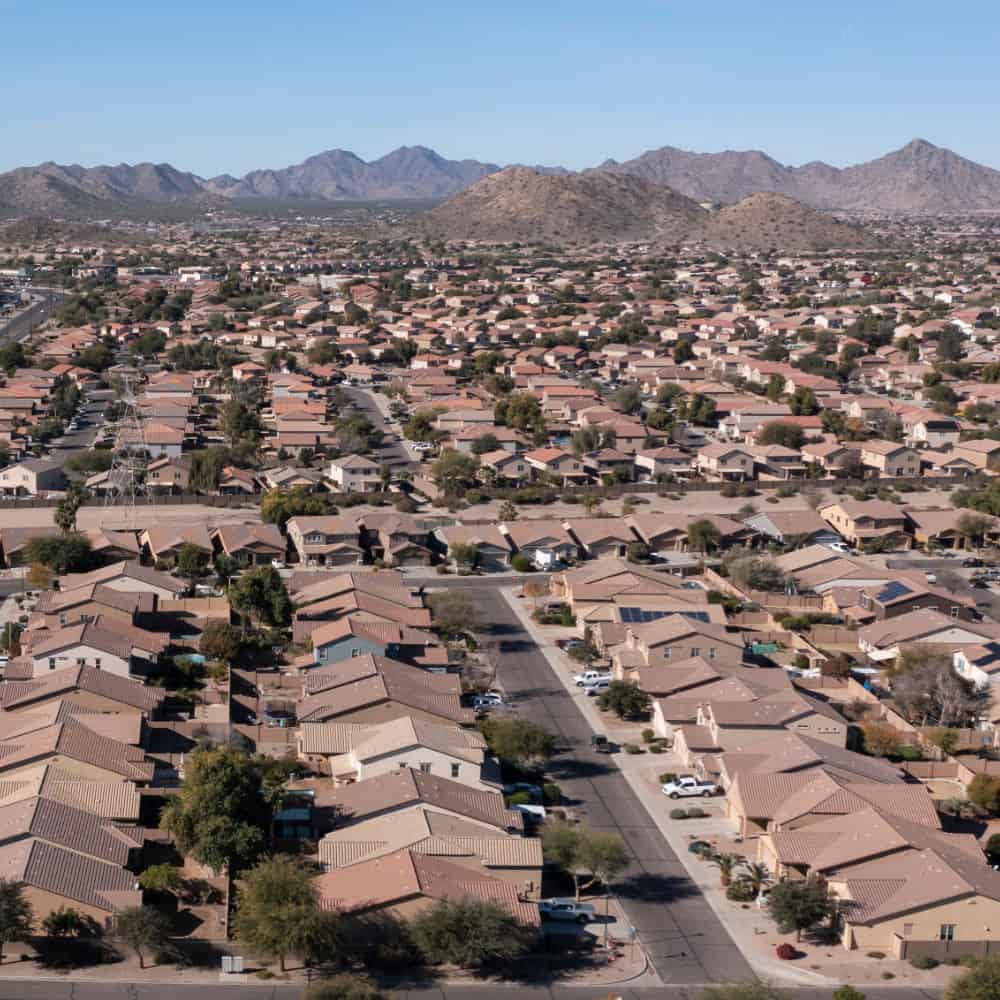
(426, 167), (708, 243)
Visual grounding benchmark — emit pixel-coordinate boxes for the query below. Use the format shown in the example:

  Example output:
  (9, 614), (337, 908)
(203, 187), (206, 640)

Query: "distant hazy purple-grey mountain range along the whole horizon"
(0, 139), (1000, 218)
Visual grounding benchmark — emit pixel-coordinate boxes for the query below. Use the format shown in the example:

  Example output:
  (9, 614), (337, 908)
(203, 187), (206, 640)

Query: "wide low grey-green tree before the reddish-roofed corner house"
(411, 898), (535, 969)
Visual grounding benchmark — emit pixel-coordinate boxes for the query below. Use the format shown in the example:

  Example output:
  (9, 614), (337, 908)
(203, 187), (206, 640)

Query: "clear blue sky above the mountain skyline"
(0, 0), (1000, 175)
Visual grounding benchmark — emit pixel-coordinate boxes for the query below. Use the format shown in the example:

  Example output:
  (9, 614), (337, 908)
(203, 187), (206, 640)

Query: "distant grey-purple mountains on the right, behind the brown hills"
(597, 139), (1000, 212)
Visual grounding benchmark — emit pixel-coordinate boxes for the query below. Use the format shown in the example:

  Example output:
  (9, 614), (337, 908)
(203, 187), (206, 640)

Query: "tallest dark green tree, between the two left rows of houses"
(160, 747), (274, 872)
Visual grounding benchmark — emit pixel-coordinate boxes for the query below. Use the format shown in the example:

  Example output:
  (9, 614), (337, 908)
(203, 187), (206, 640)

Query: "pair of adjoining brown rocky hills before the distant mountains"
(424, 167), (878, 250)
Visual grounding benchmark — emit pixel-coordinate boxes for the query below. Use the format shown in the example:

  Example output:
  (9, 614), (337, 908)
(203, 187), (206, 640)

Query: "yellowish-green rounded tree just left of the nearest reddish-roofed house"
(234, 854), (336, 972)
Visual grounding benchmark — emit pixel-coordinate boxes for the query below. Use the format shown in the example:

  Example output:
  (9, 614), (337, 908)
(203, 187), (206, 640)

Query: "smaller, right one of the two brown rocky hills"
(690, 192), (878, 250)
